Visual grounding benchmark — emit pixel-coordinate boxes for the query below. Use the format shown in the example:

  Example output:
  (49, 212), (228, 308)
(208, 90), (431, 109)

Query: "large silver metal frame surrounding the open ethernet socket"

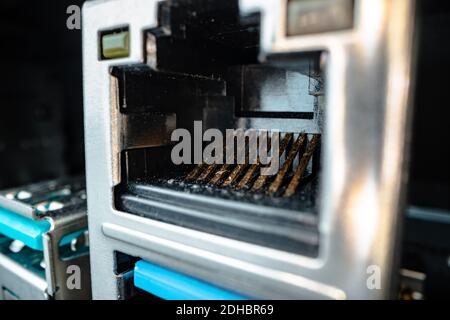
(83, 0), (414, 299)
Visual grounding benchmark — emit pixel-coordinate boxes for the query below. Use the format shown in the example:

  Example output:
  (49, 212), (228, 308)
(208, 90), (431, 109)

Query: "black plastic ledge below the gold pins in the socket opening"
(116, 184), (319, 257)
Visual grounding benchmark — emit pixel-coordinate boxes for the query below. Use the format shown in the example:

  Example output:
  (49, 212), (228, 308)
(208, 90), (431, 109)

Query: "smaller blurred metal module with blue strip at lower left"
(0, 177), (91, 300)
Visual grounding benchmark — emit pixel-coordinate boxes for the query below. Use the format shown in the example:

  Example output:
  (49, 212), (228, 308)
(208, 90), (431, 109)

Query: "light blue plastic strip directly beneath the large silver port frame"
(134, 260), (249, 300)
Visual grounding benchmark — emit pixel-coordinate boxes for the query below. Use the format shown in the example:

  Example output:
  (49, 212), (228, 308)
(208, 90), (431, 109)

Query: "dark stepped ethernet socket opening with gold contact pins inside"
(111, 1), (325, 257)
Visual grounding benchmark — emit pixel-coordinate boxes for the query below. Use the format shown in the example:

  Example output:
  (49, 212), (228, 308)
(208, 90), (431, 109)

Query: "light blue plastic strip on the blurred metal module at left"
(0, 208), (51, 251)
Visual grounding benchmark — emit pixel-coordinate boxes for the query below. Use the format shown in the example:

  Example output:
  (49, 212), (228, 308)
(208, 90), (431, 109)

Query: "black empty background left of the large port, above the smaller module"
(0, 0), (84, 188)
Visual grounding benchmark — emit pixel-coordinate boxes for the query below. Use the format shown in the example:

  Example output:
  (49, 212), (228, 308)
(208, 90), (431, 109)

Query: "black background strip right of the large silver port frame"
(409, 0), (450, 210)
